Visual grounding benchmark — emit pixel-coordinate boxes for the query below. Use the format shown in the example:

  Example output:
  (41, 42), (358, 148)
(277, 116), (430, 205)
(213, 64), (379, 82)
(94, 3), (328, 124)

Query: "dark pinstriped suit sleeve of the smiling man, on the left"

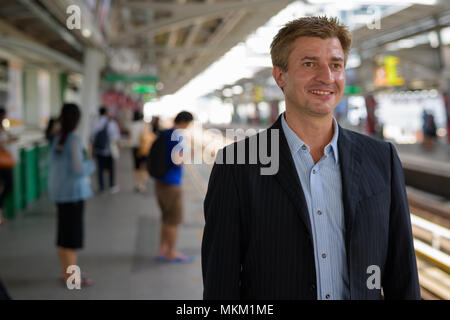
(202, 151), (241, 300)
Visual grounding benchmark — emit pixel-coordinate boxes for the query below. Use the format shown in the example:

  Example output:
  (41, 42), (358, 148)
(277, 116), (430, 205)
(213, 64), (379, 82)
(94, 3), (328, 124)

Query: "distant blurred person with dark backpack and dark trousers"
(90, 106), (120, 194)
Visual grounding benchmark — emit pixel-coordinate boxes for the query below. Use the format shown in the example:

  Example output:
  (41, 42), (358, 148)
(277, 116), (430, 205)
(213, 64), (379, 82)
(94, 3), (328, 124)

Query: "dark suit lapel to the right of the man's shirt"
(338, 126), (361, 257)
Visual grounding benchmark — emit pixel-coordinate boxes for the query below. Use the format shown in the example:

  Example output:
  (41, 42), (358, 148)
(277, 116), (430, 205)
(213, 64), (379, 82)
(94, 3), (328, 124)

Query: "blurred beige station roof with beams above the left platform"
(0, 0), (293, 94)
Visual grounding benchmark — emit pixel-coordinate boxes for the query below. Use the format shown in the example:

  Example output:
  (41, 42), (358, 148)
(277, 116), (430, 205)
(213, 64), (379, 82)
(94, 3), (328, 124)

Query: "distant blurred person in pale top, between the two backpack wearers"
(130, 111), (156, 193)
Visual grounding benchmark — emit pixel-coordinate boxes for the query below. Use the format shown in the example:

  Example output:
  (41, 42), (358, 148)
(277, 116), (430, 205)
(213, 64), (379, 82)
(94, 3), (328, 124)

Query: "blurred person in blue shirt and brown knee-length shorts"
(150, 111), (194, 263)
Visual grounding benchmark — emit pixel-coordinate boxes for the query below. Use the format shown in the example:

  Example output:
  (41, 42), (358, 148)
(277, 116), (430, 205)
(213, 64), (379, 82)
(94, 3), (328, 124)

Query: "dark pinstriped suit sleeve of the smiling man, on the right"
(383, 144), (420, 300)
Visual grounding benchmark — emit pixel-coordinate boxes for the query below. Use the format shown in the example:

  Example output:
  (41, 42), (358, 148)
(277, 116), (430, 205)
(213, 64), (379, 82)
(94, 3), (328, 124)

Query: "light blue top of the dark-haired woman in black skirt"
(48, 133), (95, 203)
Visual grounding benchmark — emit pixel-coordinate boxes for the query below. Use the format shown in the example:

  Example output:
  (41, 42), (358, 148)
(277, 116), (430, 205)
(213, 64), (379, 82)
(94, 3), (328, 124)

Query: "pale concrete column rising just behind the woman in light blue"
(78, 48), (105, 146)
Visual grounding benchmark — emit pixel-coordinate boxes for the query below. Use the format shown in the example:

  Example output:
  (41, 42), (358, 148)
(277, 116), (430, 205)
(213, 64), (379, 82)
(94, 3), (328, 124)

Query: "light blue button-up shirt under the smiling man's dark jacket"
(281, 114), (350, 300)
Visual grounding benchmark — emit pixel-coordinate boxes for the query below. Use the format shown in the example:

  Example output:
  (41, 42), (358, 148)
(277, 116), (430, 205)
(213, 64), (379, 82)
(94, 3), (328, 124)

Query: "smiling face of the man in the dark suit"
(272, 37), (345, 117)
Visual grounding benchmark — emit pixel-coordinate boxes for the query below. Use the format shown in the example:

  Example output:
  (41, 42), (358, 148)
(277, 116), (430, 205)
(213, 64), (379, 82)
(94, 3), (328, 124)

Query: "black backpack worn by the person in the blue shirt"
(147, 131), (169, 179)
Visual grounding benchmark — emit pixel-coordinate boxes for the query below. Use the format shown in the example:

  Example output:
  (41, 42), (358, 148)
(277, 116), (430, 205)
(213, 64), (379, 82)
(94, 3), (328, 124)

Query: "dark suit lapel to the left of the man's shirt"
(270, 115), (312, 237)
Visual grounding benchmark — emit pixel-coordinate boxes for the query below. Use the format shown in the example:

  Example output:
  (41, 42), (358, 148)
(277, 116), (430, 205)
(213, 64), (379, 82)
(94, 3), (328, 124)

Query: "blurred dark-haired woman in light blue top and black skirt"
(49, 103), (94, 285)
